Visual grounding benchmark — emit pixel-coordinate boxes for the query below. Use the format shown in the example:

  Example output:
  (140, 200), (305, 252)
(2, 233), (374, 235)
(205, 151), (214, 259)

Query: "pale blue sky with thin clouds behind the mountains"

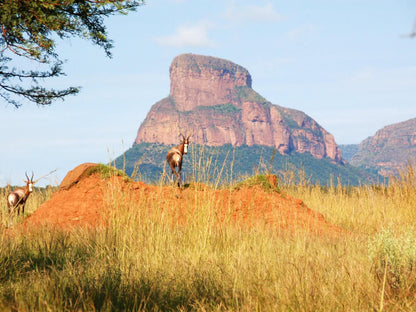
(0, 0), (416, 186)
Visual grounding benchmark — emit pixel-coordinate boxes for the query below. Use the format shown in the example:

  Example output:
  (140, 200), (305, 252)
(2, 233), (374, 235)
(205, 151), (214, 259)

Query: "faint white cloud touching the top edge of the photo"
(224, 2), (283, 22)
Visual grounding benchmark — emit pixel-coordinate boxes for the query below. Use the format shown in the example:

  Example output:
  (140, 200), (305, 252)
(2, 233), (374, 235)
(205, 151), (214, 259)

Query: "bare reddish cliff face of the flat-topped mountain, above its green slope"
(135, 54), (343, 163)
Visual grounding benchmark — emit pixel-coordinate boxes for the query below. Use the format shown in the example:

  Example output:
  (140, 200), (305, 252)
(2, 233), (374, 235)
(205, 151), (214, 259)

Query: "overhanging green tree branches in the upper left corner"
(0, 0), (144, 107)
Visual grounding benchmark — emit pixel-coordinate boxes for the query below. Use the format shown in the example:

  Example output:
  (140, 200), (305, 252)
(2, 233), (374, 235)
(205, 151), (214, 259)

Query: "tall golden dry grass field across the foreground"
(0, 165), (416, 311)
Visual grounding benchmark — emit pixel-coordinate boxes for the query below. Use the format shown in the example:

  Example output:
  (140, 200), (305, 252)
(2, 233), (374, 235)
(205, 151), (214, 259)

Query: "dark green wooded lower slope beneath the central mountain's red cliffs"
(115, 143), (377, 185)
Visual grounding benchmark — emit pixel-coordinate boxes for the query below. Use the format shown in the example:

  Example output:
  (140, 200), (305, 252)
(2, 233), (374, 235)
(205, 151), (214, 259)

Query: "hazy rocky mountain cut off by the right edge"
(350, 118), (416, 176)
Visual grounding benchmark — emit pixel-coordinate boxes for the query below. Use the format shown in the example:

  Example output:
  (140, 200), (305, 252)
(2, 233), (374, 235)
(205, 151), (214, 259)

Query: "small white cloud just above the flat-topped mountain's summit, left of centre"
(156, 21), (216, 48)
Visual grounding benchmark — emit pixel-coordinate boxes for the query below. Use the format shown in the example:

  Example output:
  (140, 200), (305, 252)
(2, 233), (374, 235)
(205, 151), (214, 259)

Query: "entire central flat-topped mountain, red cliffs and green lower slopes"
(111, 54), (394, 185)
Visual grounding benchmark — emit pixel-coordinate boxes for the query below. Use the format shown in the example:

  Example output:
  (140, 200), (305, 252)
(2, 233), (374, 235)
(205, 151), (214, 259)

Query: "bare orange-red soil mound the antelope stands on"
(23, 164), (341, 234)
